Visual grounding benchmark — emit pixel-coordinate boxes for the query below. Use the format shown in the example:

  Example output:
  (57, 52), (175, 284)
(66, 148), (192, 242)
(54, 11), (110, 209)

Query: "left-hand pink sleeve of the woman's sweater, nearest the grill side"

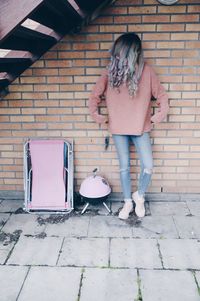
(89, 70), (108, 123)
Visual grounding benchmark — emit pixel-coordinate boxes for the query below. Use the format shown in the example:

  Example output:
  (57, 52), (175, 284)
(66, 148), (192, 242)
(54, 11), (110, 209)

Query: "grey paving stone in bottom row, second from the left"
(18, 267), (81, 301)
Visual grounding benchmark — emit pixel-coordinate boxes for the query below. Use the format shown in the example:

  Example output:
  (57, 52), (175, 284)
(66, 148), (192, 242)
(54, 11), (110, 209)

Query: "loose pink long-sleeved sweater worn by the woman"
(89, 63), (169, 135)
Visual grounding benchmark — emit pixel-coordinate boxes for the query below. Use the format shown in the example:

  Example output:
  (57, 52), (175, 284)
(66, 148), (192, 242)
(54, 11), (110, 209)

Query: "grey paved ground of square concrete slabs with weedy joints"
(0, 200), (200, 301)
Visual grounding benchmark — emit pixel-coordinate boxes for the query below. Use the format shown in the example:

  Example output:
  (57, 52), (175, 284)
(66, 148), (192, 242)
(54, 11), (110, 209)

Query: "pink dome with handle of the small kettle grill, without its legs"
(79, 168), (111, 198)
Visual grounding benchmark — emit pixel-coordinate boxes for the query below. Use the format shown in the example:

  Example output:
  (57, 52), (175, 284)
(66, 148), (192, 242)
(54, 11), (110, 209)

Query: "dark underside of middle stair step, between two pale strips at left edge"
(0, 26), (57, 56)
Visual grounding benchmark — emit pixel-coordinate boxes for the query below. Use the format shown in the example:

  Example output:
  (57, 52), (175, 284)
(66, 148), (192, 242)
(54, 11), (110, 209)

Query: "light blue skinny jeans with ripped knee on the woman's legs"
(112, 132), (153, 199)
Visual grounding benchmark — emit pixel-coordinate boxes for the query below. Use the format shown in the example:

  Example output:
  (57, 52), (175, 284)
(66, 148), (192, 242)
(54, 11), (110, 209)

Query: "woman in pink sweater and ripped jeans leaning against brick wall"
(89, 33), (169, 219)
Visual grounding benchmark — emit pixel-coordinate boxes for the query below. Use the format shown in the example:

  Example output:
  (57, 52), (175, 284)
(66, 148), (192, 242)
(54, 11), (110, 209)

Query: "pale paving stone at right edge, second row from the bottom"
(158, 239), (200, 269)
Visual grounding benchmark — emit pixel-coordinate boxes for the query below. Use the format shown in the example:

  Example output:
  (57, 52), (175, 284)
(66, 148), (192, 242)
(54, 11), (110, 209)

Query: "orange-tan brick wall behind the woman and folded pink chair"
(0, 0), (200, 193)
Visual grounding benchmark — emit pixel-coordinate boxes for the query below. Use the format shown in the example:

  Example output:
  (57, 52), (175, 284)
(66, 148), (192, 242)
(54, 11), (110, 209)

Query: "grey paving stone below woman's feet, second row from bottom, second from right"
(110, 238), (162, 269)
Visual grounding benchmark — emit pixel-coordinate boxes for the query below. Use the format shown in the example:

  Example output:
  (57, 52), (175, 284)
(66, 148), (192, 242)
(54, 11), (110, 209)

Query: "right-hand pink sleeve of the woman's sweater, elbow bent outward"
(151, 68), (169, 123)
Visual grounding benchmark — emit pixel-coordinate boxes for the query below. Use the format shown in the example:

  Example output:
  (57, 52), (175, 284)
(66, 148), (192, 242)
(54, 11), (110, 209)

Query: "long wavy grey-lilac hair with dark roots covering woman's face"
(108, 33), (144, 96)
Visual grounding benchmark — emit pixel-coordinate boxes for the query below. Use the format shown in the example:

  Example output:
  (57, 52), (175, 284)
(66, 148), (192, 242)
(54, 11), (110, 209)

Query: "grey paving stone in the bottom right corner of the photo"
(140, 270), (200, 301)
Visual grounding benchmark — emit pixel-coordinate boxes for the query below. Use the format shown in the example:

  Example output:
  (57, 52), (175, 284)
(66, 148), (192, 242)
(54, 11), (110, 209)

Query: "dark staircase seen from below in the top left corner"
(0, 0), (113, 95)
